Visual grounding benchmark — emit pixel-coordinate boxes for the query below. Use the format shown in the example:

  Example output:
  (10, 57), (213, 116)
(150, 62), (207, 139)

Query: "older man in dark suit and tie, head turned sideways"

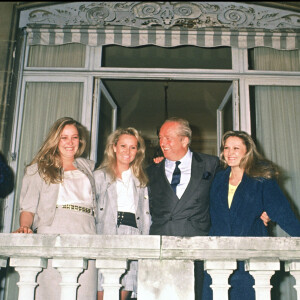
(147, 118), (219, 236)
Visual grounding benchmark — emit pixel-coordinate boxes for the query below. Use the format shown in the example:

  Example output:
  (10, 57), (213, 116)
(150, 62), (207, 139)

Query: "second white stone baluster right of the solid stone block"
(245, 258), (280, 300)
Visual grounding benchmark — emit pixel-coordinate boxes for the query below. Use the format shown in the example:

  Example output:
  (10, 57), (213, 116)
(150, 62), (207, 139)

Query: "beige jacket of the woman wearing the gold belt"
(20, 157), (96, 230)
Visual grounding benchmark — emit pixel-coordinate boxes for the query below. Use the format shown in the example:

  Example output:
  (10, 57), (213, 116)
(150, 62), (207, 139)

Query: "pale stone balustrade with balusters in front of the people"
(0, 234), (300, 300)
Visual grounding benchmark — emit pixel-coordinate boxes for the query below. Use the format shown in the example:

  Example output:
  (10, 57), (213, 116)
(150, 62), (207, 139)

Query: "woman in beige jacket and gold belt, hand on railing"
(15, 117), (97, 300)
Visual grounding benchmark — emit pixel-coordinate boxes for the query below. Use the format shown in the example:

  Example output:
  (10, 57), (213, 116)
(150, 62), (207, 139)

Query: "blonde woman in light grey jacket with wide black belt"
(94, 127), (151, 300)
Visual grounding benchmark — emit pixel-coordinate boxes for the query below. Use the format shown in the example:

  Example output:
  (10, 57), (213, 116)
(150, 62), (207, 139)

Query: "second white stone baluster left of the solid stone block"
(52, 258), (87, 300)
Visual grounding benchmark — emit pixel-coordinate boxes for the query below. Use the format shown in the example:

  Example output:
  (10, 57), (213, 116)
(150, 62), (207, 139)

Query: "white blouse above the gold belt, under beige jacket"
(57, 170), (93, 207)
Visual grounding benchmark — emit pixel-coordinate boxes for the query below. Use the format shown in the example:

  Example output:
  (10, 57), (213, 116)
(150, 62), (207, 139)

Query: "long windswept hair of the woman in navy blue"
(220, 131), (278, 178)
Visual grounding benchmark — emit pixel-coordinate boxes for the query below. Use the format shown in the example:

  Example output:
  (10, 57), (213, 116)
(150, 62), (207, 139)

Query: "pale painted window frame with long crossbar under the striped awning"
(4, 38), (300, 232)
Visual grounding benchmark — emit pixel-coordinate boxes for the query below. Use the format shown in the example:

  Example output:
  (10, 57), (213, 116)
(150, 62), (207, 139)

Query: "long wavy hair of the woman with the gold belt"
(29, 117), (87, 184)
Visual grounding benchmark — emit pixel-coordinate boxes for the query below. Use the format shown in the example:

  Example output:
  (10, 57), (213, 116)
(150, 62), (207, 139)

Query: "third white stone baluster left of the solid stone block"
(9, 257), (47, 300)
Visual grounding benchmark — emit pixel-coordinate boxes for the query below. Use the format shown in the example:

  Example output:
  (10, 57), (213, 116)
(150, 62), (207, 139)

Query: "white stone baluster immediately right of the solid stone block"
(204, 260), (237, 300)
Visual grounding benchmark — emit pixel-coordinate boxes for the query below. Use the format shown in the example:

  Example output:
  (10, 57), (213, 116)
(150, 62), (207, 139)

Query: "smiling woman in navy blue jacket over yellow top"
(202, 131), (300, 300)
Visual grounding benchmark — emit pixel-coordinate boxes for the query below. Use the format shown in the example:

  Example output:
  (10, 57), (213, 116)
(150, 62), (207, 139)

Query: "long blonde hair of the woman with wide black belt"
(98, 127), (148, 186)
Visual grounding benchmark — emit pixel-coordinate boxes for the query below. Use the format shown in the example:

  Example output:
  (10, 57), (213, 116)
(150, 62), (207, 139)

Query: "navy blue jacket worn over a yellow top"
(209, 167), (300, 237)
